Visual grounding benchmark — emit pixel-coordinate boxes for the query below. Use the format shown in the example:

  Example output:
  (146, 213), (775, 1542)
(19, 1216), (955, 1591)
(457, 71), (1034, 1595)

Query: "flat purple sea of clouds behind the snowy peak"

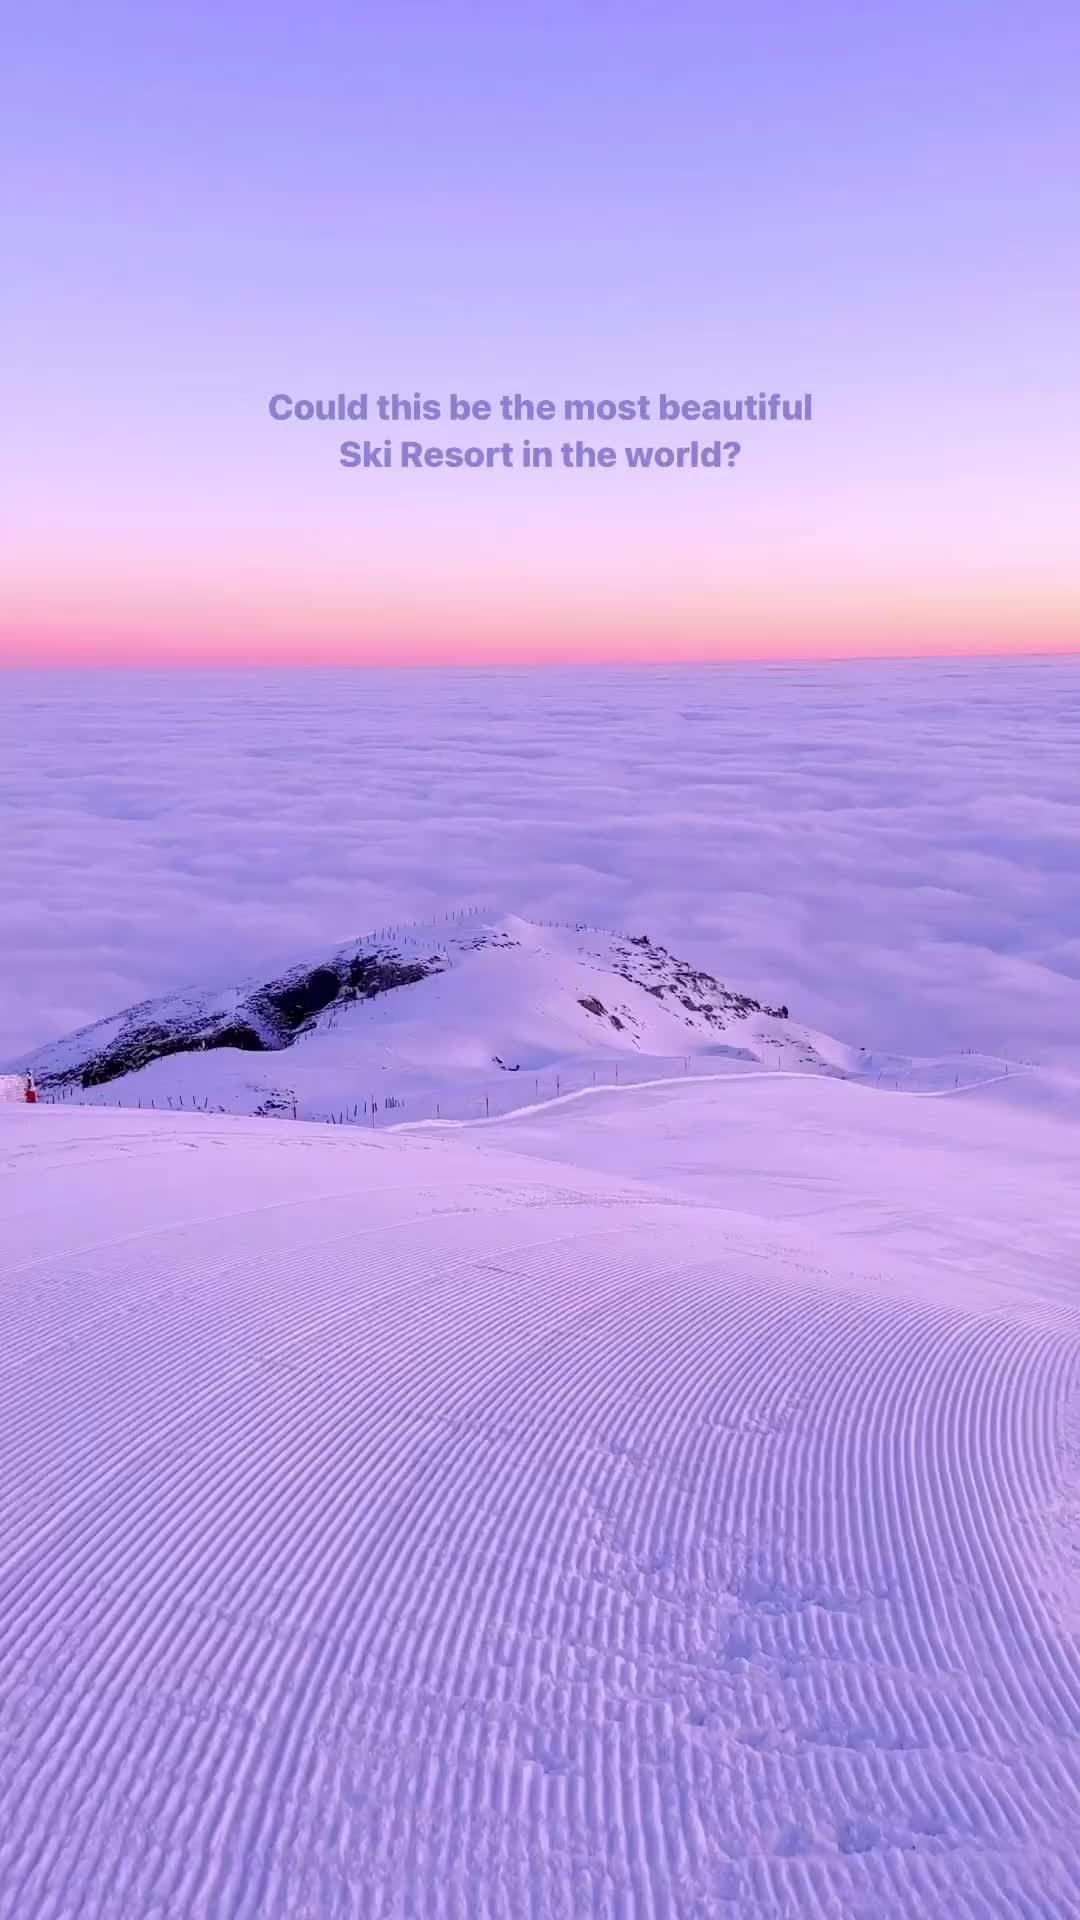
(0, 659), (1080, 1066)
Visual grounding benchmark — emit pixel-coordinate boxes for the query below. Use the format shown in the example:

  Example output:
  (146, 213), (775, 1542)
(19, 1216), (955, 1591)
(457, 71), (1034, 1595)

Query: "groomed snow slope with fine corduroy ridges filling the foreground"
(0, 1085), (1080, 1920)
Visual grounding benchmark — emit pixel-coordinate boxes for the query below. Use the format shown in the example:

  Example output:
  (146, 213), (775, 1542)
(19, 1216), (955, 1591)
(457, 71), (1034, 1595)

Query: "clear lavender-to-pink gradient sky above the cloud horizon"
(0, 0), (1080, 662)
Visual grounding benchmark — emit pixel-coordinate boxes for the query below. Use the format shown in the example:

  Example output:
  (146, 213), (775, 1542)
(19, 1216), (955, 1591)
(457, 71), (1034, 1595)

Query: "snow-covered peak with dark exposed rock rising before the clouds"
(17, 916), (861, 1119)
